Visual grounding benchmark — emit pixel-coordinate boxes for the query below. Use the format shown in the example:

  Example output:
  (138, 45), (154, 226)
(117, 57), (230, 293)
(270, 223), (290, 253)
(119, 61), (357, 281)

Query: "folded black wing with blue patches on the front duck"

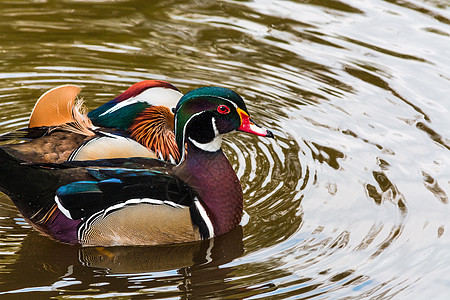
(55, 168), (194, 219)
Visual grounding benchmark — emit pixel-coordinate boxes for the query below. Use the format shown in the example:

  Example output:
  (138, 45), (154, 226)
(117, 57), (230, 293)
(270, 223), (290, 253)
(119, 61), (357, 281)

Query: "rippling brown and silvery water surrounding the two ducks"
(0, 0), (450, 299)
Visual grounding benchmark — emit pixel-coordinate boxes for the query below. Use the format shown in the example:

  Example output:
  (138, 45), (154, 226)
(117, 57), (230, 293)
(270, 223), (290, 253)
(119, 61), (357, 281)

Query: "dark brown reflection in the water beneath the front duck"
(0, 226), (244, 298)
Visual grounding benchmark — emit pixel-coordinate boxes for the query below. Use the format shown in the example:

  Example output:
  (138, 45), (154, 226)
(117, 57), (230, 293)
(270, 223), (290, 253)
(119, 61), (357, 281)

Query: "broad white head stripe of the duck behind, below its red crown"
(100, 87), (183, 116)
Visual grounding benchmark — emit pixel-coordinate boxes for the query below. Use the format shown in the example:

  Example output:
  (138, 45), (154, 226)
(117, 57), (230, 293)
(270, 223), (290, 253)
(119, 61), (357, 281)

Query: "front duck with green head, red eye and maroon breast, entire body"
(0, 87), (274, 246)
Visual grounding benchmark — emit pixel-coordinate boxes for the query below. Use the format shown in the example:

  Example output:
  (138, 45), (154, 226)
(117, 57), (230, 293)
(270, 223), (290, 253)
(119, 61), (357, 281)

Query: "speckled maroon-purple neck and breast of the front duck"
(174, 141), (243, 236)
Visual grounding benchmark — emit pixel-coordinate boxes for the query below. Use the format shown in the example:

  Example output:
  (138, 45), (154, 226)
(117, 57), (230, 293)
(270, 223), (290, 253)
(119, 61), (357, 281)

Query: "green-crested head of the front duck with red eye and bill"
(175, 87), (273, 160)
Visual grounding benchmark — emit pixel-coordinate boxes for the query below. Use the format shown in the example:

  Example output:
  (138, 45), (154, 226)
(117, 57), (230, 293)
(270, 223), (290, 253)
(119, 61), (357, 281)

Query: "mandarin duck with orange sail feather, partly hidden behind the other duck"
(0, 80), (183, 163)
